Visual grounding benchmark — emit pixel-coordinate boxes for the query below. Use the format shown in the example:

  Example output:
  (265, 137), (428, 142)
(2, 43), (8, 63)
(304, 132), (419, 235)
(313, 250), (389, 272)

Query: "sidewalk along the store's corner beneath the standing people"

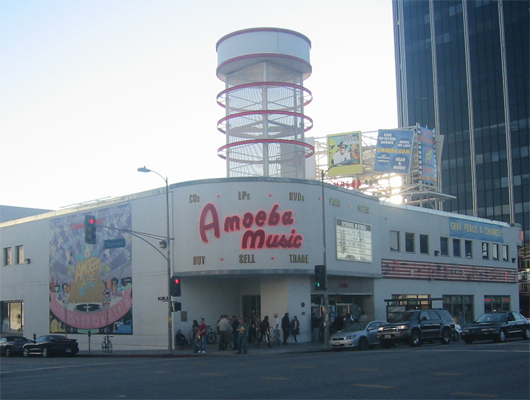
(76, 342), (330, 358)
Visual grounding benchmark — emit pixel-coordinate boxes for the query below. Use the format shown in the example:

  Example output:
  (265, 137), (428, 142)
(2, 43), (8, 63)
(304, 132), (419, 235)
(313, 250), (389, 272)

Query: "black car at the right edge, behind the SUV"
(461, 311), (530, 344)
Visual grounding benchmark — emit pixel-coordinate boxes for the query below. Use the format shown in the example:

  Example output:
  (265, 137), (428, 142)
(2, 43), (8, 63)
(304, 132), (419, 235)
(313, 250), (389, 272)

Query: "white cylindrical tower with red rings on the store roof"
(217, 28), (314, 178)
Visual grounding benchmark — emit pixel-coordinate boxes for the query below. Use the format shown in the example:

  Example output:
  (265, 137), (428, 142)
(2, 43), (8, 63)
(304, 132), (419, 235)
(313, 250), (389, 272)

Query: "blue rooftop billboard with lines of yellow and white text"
(374, 129), (414, 174)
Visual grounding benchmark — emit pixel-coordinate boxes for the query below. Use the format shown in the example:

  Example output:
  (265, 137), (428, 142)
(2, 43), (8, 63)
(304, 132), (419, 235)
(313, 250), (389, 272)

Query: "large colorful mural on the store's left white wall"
(49, 204), (133, 334)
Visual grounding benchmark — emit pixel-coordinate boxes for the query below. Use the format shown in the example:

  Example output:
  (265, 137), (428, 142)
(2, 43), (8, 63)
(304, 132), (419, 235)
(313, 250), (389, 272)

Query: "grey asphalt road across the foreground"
(0, 340), (530, 400)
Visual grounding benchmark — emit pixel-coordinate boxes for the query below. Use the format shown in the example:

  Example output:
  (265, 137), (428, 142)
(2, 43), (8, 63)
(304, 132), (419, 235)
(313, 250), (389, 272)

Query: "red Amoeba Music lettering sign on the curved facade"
(199, 203), (304, 250)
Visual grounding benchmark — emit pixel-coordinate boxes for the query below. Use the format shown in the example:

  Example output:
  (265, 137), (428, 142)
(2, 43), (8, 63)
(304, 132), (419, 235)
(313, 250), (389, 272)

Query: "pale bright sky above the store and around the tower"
(0, 0), (397, 210)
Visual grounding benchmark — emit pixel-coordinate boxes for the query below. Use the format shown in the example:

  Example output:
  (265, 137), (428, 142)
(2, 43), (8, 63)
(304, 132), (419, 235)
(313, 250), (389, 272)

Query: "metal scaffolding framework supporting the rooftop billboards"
(314, 125), (455, 210)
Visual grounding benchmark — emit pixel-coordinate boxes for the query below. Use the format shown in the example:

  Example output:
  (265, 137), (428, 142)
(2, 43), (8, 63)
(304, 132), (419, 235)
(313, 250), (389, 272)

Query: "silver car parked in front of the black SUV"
(329, 321), (386, 350)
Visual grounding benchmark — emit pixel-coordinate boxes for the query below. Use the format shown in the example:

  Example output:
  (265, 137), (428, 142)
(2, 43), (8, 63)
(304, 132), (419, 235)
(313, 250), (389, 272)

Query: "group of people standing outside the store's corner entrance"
(175, 313), (300, 354)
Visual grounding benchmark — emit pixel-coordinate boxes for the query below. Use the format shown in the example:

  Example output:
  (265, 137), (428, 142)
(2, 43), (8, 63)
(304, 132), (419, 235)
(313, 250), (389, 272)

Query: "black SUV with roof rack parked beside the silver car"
(377, 309), (455, 348)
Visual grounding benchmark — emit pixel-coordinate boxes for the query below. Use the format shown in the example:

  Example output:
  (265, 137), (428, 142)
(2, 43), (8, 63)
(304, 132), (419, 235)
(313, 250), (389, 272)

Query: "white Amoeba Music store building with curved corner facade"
(0, 178), (521, 350)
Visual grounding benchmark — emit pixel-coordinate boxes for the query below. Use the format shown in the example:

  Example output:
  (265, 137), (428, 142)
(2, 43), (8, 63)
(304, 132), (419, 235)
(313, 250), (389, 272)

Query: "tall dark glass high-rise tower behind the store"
(393, 0), (530, 296)
